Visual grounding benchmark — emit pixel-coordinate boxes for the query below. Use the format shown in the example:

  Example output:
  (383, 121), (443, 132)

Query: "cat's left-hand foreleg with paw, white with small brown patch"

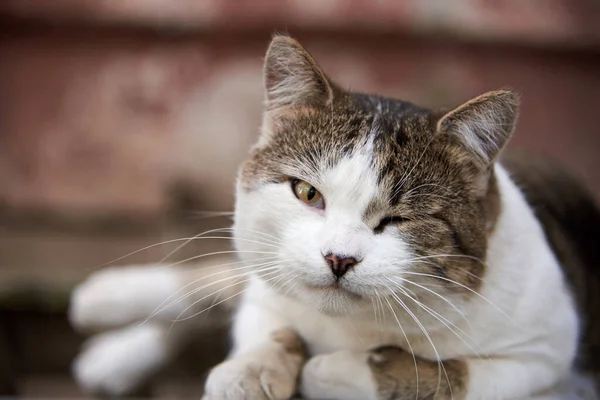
(205, 303), (306, 400)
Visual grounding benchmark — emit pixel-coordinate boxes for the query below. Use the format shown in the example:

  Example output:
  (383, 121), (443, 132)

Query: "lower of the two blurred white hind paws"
(73, 324), (169, 396)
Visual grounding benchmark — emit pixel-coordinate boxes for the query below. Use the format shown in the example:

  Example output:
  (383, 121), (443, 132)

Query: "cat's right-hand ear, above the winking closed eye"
(437, 90), (519, 169)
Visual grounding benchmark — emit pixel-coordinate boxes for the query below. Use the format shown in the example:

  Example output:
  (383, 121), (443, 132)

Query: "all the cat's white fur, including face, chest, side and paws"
(72, 148), (578, 400)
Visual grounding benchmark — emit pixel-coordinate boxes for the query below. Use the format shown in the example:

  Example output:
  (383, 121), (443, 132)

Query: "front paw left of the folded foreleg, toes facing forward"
(203, 359), (296, 400)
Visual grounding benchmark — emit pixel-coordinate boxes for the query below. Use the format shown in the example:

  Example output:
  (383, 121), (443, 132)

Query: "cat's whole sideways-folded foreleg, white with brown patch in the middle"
(301, 347), (560, 400)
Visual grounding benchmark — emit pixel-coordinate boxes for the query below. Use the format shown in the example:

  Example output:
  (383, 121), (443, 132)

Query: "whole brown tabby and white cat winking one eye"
(70, 35), (600, 400)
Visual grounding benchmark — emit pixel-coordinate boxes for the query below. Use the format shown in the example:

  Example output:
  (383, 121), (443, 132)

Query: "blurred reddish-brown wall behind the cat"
(0, 0), (600, 217)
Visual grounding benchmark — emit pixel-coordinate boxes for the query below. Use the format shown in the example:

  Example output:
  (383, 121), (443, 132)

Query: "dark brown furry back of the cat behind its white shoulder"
(500, 151), (600, 371)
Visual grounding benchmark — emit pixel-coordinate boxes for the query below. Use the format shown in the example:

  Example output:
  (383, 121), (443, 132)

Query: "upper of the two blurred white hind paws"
(69, 267), (187, 330)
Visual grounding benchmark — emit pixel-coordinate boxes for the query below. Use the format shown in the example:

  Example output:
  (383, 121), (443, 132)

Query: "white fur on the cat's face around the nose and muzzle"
(234, 145), (410, 313)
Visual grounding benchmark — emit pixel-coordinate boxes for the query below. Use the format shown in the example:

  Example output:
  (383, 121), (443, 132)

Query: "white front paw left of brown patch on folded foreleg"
(300, 351), (377, 400)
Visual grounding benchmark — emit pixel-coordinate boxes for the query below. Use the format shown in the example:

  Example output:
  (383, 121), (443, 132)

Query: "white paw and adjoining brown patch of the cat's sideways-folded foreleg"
(301, 347), (467, 400)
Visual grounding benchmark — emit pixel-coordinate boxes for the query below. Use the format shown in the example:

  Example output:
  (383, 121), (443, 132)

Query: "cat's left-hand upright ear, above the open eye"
(264, 35), (334, 111)
